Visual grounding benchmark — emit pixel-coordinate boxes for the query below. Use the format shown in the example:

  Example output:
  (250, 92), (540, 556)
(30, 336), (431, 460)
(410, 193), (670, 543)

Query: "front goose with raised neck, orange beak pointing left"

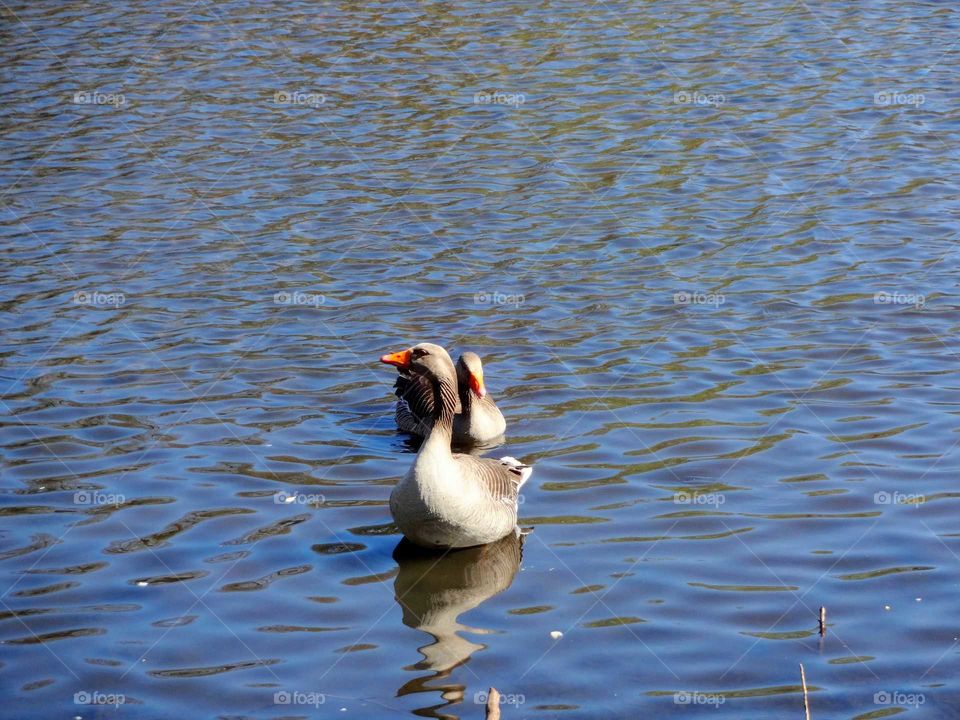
(380, 343), (533, 548)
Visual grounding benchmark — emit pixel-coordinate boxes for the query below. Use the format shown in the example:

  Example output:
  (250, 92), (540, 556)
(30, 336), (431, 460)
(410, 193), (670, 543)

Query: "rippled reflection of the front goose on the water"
(393, 531), (524, 720)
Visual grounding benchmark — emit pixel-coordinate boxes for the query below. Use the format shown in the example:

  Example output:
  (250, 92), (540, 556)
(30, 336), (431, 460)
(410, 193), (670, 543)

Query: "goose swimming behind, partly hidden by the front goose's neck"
(394, 352), (507, 445)
